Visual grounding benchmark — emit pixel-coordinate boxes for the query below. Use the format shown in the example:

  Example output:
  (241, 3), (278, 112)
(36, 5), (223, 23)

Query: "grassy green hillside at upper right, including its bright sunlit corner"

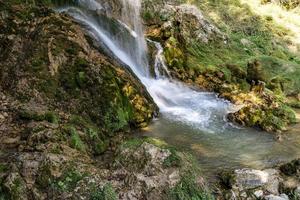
(188, 0), (300, 94)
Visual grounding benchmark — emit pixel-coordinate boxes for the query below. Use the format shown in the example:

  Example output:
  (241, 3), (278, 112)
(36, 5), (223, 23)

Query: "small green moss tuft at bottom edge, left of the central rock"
(90, 183), (118, 200)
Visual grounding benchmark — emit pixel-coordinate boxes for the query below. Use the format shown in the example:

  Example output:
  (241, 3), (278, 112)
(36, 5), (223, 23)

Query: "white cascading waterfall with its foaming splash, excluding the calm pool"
(60, 0), (230, 132)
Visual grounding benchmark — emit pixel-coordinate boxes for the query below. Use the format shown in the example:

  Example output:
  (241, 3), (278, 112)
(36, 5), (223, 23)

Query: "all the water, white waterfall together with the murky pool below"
(59, 0), (300, 175)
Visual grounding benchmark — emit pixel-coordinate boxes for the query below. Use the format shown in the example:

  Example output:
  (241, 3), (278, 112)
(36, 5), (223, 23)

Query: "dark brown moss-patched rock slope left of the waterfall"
(0, 0), (158, 199)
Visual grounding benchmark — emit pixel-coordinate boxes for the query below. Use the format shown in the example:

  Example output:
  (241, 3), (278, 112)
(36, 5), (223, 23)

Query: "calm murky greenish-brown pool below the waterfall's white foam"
(138, 110), (300, 176)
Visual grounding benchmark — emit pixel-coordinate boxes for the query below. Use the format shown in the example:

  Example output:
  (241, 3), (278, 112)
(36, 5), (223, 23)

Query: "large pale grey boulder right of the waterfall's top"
(142, 1), (226, 45)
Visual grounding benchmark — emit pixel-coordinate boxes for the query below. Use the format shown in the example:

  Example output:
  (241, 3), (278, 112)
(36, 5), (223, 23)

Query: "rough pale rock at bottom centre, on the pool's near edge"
(112, 143), (181, 200)
